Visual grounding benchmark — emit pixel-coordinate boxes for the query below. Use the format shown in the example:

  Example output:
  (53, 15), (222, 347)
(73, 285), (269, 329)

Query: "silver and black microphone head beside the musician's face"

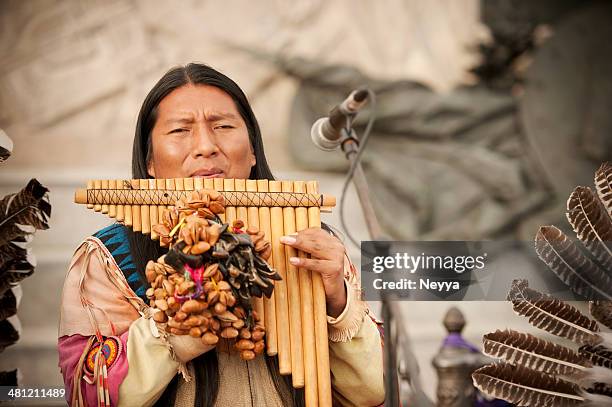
(310, 89), (368, 151)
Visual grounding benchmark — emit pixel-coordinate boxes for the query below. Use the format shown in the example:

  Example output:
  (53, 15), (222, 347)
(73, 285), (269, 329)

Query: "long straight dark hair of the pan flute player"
(127, 63), (304, 407)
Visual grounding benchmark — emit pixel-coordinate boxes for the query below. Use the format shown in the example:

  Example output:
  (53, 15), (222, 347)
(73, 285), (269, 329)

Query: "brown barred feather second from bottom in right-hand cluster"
(483, 330), (592, 377)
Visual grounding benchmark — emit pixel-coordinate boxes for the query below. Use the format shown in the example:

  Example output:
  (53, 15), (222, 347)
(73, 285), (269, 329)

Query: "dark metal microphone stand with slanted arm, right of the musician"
(341, 126), (405, 407)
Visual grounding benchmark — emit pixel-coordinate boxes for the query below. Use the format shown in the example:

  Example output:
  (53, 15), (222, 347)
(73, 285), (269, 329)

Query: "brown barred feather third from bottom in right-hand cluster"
(508, 280), (603, 345)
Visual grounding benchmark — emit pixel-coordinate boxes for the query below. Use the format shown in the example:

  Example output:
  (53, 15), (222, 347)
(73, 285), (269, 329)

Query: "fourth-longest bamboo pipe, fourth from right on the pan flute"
(268, 181), (291, 375)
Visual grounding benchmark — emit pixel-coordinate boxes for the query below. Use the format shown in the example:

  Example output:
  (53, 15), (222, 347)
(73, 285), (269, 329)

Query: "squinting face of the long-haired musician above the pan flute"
(148, 84), (255, 178)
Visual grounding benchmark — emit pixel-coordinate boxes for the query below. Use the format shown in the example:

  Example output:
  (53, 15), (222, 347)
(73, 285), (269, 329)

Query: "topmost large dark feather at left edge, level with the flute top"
(0, 179), (51, 246)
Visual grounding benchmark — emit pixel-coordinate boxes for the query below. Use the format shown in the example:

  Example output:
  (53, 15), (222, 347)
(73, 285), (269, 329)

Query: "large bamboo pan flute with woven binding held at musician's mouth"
(75, 178), (335, 406)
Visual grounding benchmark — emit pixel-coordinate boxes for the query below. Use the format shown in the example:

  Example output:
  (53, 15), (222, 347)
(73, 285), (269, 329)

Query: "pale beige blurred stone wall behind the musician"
(0, 0), (564, 398)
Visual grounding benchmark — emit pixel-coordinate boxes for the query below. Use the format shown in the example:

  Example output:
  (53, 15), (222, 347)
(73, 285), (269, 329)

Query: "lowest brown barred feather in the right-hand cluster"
(472, 363), (585, 407)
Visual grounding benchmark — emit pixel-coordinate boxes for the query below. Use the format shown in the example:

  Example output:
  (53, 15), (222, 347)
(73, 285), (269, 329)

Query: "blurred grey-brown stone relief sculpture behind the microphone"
(248, 0), (612, 244)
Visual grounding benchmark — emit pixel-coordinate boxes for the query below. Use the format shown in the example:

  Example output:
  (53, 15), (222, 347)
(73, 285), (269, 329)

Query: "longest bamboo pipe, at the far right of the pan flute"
(306, 181), (332, 407)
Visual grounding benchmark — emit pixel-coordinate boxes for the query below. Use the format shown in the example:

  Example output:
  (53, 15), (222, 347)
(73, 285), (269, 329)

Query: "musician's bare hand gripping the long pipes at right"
(280, 228), (346, 318)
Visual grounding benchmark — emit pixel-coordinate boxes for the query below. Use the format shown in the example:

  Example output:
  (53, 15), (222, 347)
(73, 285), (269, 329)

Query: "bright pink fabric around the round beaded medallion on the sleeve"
(57, 331), (129, 406)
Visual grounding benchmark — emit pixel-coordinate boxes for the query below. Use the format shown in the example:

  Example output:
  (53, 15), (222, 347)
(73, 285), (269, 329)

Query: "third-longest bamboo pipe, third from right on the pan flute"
(281, 181), (304, 388)
